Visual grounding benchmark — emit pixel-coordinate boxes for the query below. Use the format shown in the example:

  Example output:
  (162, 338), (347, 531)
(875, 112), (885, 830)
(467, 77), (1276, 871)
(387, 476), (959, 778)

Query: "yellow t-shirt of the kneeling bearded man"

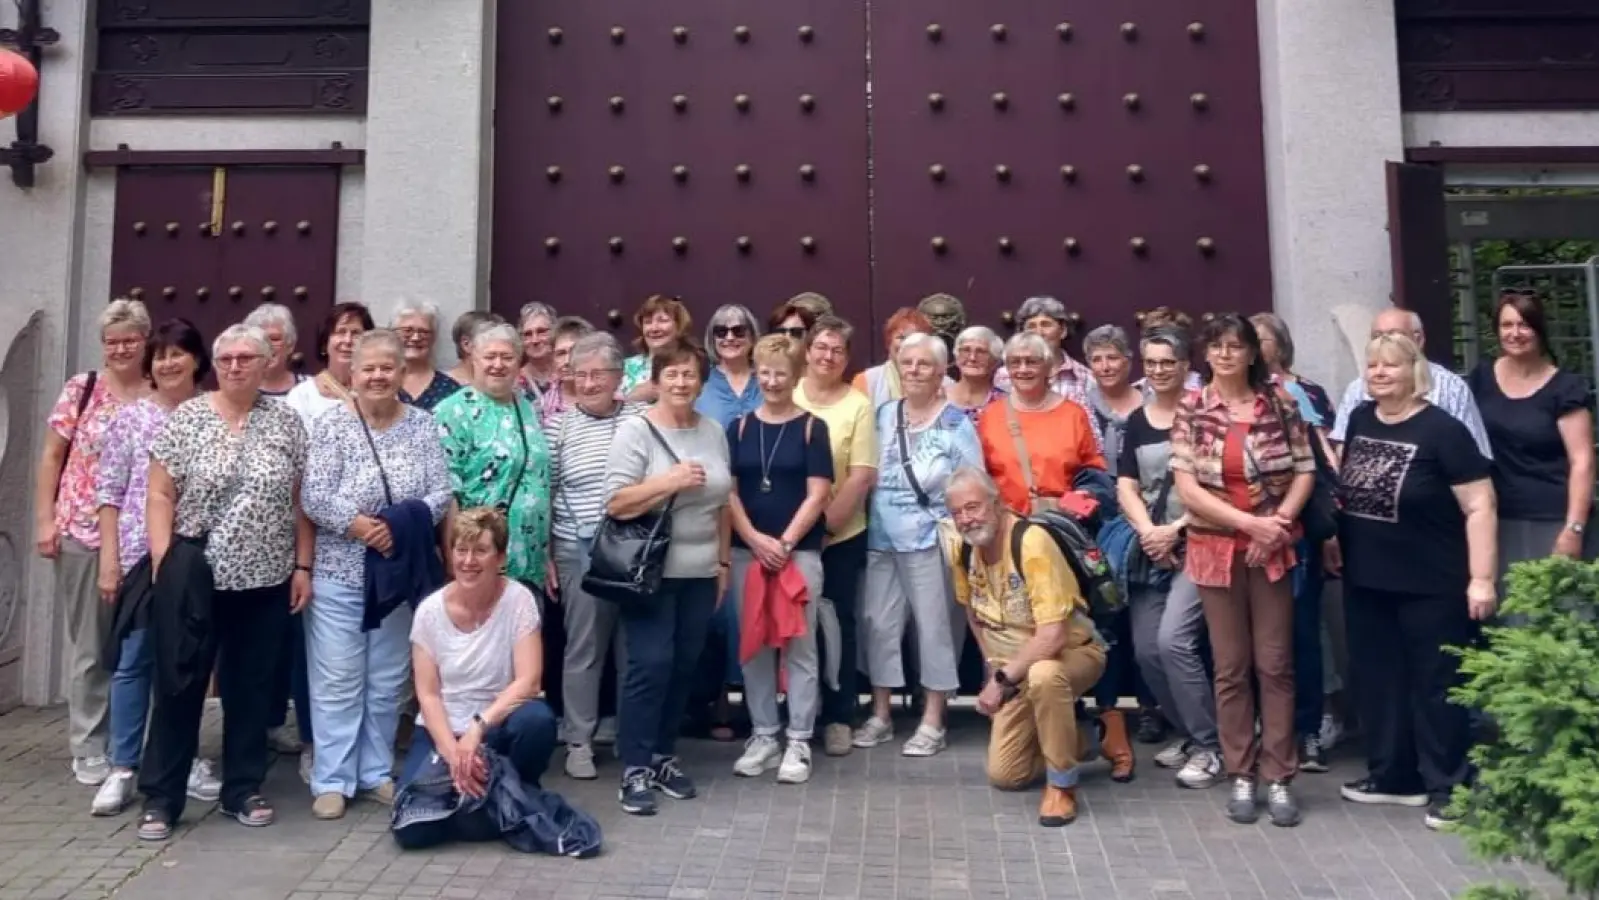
(939, 520), (1094, 665)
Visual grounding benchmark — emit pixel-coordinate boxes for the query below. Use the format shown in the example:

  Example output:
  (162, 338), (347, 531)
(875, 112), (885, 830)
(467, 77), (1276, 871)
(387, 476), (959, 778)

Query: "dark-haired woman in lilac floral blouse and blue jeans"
(90, 318), (222, 815)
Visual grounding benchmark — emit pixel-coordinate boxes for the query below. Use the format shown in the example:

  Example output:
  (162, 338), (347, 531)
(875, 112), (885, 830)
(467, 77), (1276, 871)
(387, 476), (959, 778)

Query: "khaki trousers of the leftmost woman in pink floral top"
(56, 537), (114, 758)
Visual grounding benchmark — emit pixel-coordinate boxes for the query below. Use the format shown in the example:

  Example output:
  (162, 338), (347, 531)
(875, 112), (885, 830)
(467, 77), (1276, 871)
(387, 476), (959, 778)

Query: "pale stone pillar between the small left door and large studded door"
(360, 0), (494, 334)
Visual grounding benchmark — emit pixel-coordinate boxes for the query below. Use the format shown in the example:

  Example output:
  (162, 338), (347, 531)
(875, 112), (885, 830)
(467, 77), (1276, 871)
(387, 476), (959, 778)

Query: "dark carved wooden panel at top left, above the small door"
(91, 0), (371, 115)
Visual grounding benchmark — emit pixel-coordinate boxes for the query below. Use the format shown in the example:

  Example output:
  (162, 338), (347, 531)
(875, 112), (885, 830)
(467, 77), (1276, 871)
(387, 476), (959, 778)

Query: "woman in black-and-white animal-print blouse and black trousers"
(139, 325), (315, 841)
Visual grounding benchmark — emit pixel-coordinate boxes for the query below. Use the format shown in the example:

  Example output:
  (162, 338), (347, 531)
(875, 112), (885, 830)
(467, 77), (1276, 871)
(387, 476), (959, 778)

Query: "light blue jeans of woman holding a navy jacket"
(305, 579), (411, 798)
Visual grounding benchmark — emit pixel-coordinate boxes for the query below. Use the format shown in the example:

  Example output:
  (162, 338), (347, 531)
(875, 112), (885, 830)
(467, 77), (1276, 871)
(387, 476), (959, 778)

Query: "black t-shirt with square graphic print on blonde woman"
(1338, 401), (1489, 596)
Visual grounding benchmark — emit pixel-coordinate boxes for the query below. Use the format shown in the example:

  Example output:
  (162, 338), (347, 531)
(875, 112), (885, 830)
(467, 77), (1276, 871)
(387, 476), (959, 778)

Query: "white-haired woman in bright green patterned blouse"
(433, 325), (550, 591)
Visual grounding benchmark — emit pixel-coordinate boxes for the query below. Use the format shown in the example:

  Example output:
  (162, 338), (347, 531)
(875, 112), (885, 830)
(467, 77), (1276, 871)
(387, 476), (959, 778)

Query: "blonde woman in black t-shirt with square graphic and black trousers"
(1326, 334), (1495, 828)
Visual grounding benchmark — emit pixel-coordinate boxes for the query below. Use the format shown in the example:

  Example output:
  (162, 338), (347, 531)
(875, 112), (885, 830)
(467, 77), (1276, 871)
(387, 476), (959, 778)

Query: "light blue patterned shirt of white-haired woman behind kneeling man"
(867, 401), (983, 553)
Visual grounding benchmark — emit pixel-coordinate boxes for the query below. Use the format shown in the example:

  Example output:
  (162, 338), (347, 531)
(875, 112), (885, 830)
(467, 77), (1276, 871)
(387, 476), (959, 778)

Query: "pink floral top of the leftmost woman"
(46, 374), (134, 550)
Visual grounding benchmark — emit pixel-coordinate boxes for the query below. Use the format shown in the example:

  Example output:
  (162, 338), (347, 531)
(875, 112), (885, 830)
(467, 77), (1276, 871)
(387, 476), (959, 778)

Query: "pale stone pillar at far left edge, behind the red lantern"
(0, 0), (93, 707)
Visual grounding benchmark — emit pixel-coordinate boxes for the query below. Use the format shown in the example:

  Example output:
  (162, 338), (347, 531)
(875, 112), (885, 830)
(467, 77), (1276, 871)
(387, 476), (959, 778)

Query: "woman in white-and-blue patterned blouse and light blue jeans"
(305, 331), (451, 818)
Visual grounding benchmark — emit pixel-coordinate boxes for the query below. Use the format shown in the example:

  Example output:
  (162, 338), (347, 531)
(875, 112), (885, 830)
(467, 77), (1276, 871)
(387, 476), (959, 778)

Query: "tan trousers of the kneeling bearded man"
(988, 644), (1105, 791)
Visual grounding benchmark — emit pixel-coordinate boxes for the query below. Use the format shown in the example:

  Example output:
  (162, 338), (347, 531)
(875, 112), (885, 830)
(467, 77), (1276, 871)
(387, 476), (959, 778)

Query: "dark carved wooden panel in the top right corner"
(1396, 0), (1599, 110)
